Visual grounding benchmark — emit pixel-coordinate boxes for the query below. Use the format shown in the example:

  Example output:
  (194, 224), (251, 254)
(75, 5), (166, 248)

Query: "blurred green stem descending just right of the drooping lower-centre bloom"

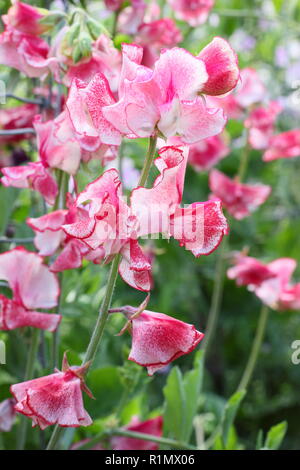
(202, 238), (228, 357)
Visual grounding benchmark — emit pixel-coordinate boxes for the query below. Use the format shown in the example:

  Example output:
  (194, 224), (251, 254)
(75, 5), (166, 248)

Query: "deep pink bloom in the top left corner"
(2, 0), (49, 36)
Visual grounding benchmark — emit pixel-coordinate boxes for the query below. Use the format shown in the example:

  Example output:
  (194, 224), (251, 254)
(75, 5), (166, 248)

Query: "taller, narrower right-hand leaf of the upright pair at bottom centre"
(183, 351), (203, 442)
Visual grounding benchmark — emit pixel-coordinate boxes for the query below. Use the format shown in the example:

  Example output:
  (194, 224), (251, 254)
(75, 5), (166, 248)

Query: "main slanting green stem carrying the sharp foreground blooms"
(47, 135), (157, 450)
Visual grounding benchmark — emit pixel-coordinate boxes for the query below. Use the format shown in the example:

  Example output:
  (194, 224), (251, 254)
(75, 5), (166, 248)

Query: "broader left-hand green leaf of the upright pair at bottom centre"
(163, 367), (186, 441)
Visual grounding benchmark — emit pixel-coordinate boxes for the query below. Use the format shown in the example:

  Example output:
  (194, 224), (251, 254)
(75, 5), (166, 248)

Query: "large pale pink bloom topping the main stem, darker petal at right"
(103, 38), (239, 144)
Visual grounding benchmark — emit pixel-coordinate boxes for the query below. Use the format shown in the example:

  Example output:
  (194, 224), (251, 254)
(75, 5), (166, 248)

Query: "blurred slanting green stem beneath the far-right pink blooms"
(237, 305), (269, 391)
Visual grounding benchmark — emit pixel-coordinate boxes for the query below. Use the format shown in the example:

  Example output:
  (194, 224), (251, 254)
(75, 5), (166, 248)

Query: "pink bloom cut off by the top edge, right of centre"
(168, 0), (215, 26)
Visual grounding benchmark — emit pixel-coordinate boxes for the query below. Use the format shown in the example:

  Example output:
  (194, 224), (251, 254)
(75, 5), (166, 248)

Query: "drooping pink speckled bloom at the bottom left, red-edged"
(10, 357), (92, 430)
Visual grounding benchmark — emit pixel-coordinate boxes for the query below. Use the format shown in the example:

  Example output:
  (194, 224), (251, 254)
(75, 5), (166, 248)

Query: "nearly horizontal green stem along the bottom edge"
(76, 429), (197, 450)
